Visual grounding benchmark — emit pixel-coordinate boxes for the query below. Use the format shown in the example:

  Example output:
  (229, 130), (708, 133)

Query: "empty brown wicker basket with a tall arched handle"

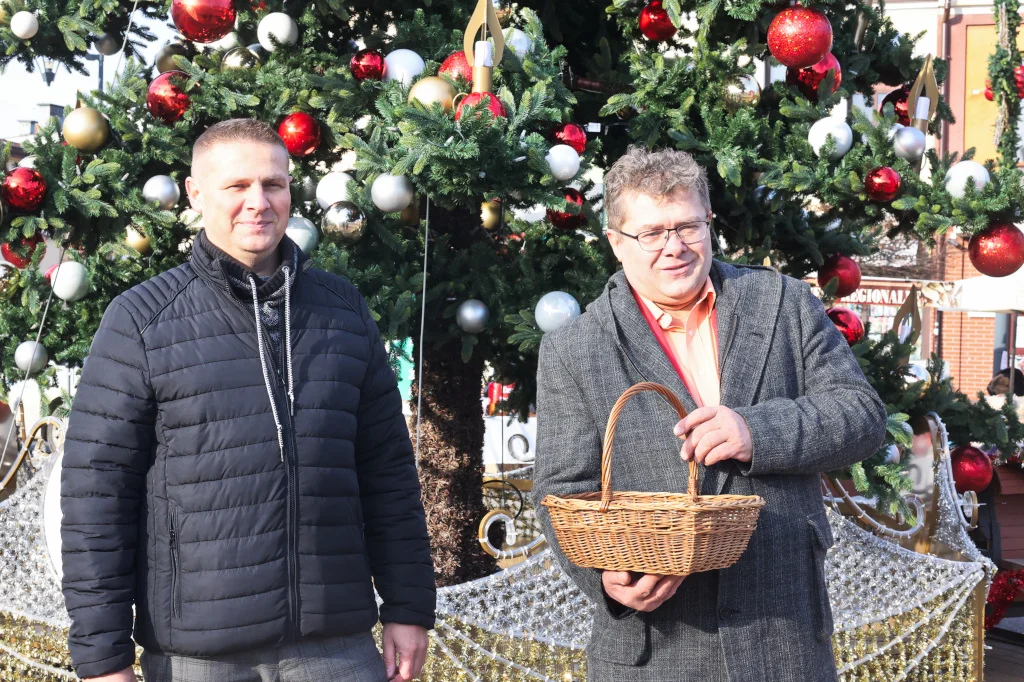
(541, 382), (765, 576)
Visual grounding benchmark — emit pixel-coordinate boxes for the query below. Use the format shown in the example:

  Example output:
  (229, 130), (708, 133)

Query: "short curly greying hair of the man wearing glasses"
(604, 145), (711, 229)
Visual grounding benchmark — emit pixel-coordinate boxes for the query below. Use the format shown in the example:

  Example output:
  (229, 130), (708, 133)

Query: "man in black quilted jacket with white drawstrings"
(61, 119), (435, 682)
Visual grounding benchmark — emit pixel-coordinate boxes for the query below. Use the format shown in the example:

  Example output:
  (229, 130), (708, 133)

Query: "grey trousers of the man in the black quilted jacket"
(139, 632), (386, 682)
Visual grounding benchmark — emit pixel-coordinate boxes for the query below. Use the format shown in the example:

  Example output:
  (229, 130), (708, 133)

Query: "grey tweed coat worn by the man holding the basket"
(534, 261), (886, 682)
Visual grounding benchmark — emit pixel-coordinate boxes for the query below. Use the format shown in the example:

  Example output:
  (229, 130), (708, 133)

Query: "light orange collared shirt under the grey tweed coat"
(634, 278), (721, 408)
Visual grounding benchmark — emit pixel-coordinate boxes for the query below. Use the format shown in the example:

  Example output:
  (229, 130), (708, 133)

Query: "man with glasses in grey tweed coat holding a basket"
(534, 148), (886, 682)
